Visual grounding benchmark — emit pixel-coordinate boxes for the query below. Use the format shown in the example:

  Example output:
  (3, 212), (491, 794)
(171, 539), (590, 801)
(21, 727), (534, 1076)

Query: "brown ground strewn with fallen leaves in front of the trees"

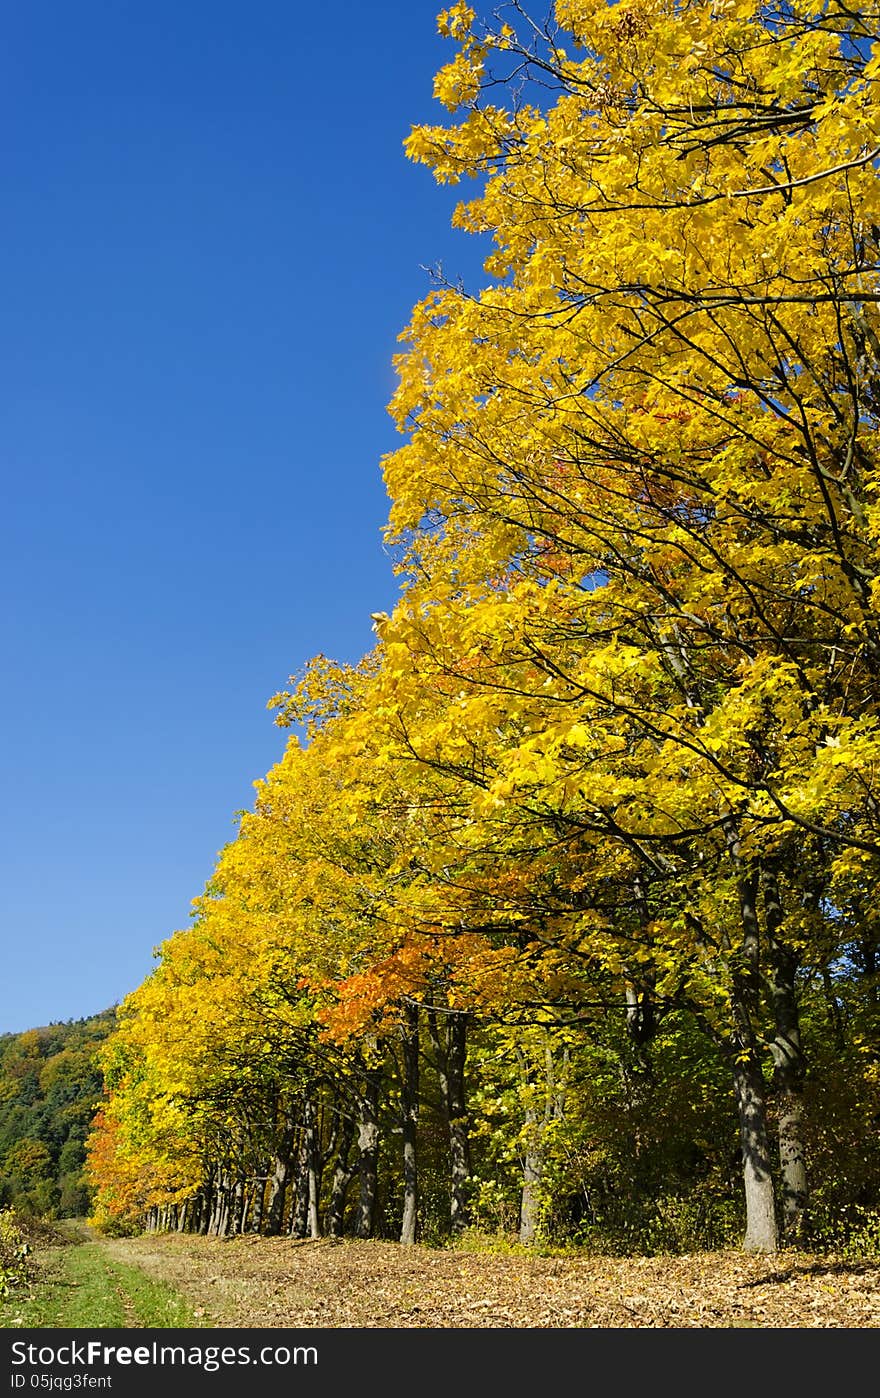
(99, 1234), (880, 1329)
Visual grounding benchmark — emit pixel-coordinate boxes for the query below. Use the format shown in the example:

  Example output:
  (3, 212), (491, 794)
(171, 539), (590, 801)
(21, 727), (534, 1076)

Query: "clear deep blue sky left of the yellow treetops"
(0, 0), (481, 1032)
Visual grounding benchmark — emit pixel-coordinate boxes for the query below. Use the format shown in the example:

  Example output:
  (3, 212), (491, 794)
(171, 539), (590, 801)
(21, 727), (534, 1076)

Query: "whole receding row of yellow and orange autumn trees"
(85, 0), (880, 1251)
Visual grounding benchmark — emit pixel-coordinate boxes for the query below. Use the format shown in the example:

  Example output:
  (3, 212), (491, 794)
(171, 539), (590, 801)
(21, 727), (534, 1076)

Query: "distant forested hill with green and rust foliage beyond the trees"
(0, 1009), (116, 1218)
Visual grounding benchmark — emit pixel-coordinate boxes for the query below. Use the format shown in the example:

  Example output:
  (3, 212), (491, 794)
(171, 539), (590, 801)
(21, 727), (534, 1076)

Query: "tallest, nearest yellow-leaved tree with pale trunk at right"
(374, 0), (879, 1250)
